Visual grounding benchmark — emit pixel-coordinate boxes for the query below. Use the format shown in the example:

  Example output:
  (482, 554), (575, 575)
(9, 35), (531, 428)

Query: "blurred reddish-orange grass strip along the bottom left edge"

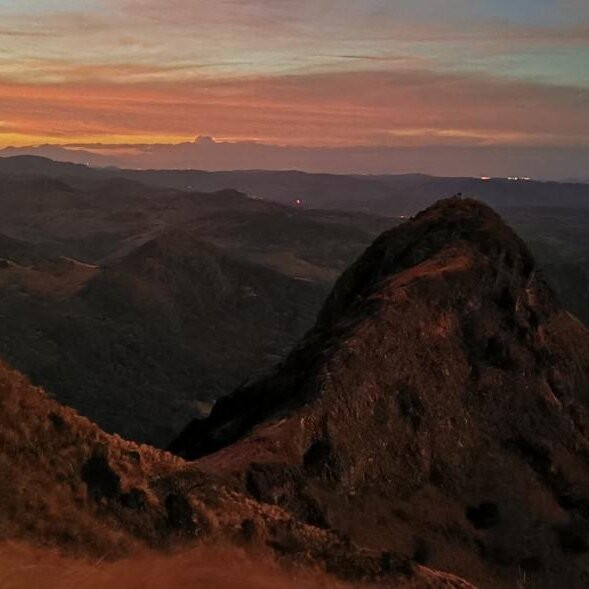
(0, 543), (358, 589)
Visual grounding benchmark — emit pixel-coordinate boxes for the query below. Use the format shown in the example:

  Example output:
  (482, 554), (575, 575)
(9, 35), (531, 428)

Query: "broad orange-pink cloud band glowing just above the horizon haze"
(0, 66), (589, 146)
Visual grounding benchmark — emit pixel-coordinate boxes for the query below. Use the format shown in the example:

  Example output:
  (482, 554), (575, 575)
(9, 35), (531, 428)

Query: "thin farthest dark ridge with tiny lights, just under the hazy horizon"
(0, 156), (589, 216)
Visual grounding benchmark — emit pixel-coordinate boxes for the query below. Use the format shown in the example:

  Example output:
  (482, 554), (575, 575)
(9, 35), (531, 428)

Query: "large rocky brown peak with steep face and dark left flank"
(171, 199), (589, 588)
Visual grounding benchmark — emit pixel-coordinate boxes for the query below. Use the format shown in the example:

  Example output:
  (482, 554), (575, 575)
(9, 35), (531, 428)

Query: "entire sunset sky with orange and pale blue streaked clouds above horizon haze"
(0, 0), (589, 175)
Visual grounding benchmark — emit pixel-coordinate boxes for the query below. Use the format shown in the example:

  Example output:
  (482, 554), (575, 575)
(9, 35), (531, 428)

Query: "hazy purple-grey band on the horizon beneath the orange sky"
(0, 137), (589, 179)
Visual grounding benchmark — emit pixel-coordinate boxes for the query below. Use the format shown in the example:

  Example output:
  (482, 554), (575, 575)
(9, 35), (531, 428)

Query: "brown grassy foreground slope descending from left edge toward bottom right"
(0, 363), (469, 589)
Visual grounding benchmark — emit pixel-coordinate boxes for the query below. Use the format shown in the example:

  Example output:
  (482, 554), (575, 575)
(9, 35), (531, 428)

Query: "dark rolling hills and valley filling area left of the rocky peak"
(0, 176), (394, 446)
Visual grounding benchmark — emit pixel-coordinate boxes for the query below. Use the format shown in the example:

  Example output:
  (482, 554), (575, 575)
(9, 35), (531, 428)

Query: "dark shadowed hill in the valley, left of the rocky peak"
(0, 231), (327, 445)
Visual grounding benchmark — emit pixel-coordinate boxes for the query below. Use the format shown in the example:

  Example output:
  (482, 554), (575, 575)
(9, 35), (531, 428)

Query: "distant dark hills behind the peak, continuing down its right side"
(0, 156), (589, 321)
